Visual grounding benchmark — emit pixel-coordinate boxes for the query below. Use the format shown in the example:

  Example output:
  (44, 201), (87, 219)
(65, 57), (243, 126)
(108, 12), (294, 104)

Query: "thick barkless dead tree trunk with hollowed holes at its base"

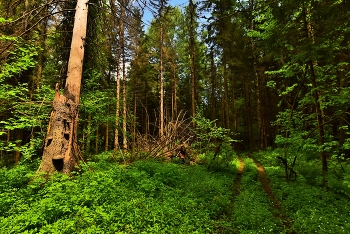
(38, 0), (89, 174)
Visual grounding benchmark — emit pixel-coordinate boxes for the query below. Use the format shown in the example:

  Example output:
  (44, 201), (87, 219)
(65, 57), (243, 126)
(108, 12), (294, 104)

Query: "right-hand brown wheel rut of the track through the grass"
(253, 156), (295, 234)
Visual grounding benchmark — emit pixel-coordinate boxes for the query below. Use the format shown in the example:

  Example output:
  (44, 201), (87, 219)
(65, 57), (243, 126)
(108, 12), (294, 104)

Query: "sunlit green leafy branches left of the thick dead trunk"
(0, 35), (53, 165)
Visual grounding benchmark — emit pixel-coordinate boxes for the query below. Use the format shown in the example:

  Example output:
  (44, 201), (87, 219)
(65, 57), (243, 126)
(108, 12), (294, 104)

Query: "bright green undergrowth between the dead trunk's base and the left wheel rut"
(0, 154), (235, 234)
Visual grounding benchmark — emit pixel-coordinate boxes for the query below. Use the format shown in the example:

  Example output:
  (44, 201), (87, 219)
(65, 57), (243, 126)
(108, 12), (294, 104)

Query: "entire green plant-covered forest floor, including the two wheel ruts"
(0, 151), (350, 233)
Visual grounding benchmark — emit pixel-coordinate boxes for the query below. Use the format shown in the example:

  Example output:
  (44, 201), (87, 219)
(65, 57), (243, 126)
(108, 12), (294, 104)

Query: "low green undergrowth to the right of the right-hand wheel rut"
(253, 150), (350, 233)
